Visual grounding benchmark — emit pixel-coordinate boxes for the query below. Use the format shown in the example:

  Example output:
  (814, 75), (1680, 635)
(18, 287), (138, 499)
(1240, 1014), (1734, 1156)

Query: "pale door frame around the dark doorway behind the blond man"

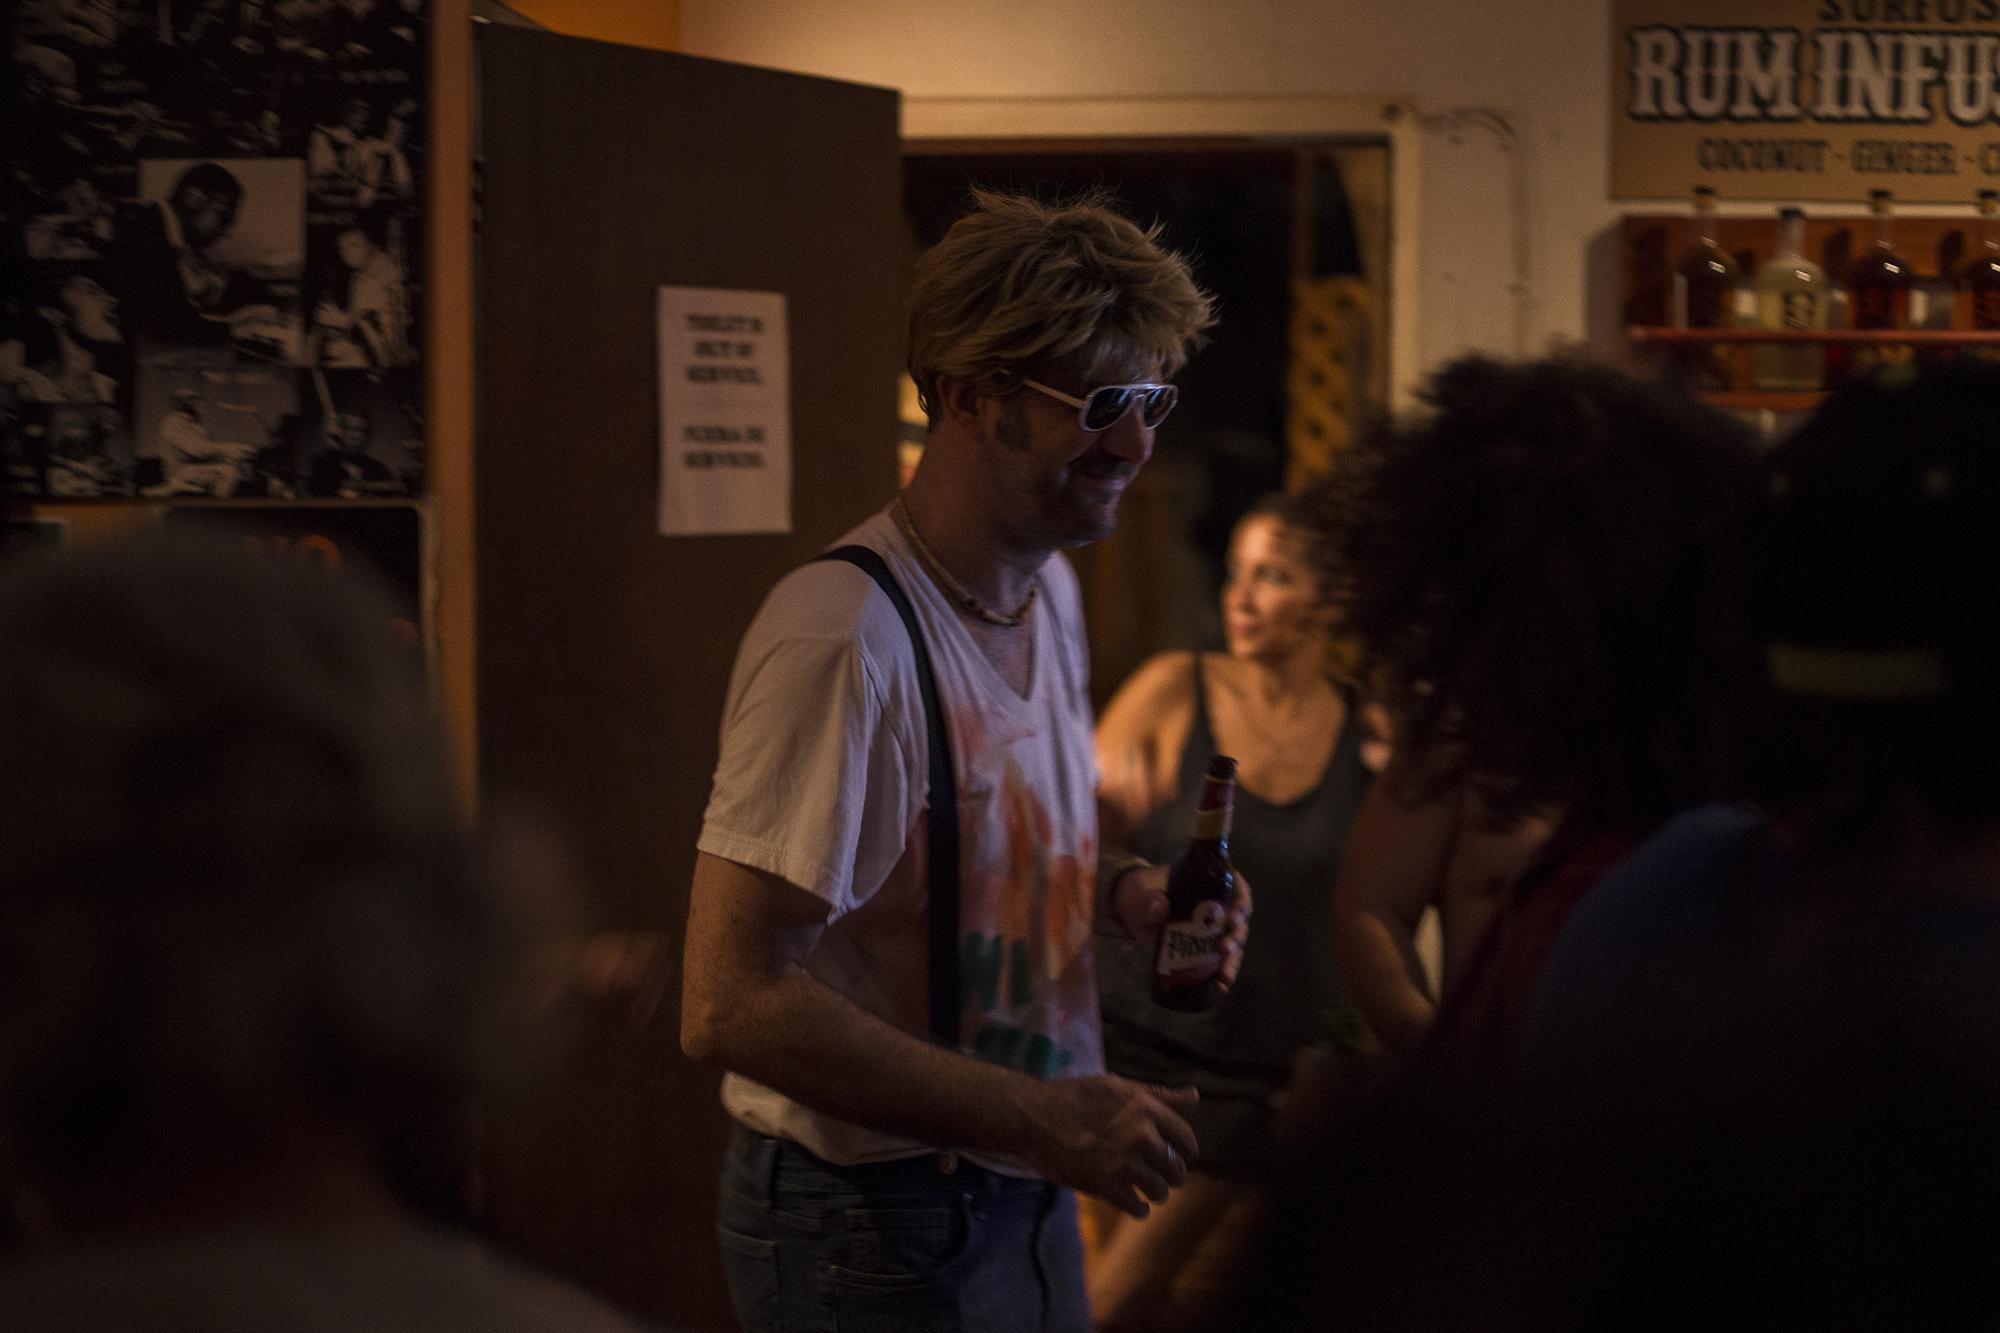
(902, 94), (1422, 410)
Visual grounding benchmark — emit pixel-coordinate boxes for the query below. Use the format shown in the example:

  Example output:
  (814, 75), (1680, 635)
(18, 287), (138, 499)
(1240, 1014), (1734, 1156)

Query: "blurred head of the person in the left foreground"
(0, 534), (556, 1197)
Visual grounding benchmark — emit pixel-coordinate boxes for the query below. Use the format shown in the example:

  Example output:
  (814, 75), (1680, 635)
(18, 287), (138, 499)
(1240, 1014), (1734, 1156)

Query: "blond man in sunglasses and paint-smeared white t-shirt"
(682, 194), (1242, 1333)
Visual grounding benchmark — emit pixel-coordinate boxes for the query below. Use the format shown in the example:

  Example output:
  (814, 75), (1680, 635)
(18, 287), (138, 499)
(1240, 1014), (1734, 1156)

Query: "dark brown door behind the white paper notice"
(474, 26), (908, 1329)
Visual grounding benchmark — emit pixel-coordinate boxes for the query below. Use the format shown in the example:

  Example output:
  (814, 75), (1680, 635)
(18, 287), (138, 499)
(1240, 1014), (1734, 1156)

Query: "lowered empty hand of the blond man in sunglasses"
(1022, 1075), (1198, 1217)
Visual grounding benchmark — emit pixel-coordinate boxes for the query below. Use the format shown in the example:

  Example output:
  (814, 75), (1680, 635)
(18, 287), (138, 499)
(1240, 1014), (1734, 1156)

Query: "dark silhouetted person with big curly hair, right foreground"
(1214, 358), (1784, 1333)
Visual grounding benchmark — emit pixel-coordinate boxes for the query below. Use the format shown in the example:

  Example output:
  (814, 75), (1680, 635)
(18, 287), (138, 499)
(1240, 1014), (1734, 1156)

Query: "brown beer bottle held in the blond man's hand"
(1152, 755), (1236, 1000)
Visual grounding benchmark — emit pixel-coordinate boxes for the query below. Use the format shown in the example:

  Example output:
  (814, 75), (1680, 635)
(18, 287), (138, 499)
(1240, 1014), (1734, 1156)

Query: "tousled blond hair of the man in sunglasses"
(910, 190), (1216, 422)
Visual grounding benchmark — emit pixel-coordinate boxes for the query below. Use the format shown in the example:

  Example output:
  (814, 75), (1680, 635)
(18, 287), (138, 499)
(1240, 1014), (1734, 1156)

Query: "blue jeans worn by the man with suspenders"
(716, 1125), (1090, 1333)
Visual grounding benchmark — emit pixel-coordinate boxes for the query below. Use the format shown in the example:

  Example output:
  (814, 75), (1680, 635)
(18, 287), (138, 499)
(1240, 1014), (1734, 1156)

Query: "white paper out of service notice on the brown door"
(660, 286), (792, 536)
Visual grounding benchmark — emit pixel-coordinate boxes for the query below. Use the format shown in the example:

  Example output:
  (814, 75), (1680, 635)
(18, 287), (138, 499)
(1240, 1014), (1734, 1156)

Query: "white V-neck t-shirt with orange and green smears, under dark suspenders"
(700, 510), (1104, 1171)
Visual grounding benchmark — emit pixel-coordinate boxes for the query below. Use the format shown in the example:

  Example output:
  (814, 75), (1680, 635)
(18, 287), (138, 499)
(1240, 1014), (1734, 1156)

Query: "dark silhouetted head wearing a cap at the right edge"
(1754, 360), (2000, 823)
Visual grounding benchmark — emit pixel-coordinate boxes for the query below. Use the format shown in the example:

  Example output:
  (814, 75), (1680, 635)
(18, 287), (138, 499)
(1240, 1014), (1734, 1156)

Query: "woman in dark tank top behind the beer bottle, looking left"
(1090, 494), (1384, 1329)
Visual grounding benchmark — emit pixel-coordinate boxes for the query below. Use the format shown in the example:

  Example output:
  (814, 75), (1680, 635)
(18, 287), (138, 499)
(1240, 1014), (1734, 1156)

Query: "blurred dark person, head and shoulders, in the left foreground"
(0, 534), (648, 1333)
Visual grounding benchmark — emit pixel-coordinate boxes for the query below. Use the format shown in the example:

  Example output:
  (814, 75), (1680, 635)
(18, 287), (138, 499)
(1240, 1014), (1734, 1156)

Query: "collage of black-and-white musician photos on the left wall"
(0, 0), (428, 500)
